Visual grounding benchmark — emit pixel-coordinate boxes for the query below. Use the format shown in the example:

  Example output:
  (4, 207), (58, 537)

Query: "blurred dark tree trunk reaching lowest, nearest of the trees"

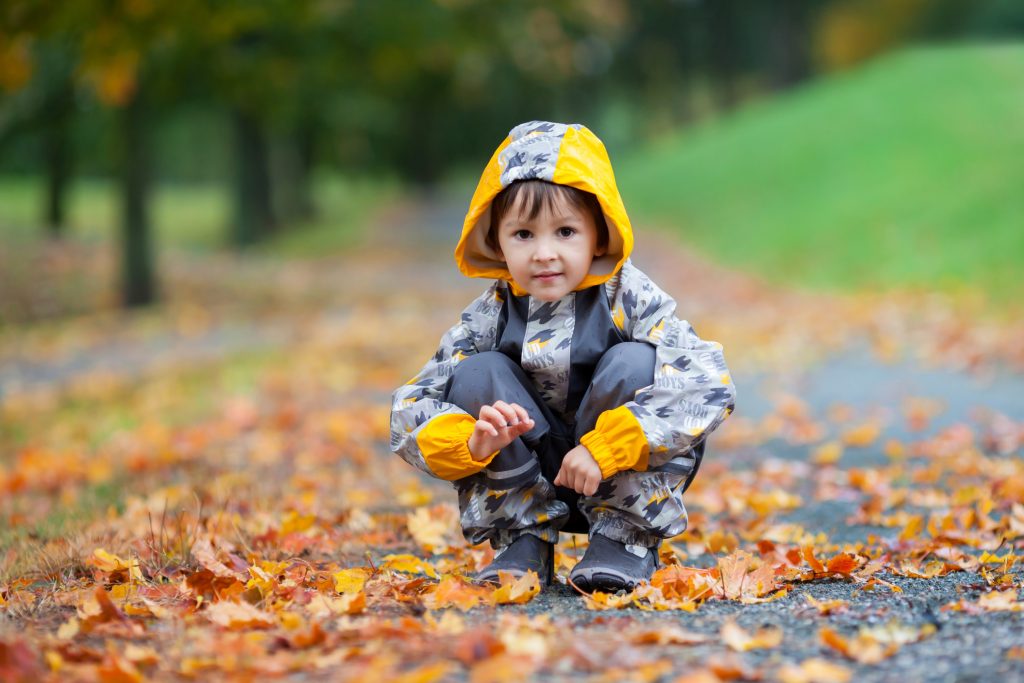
(120, 92), (156, 307)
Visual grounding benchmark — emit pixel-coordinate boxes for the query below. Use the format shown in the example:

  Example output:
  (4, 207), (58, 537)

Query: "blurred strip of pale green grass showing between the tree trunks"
(0, 176), (397, 256)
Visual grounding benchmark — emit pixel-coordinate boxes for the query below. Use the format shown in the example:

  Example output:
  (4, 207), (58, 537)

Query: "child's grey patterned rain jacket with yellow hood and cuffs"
(391, 122), (735, 480)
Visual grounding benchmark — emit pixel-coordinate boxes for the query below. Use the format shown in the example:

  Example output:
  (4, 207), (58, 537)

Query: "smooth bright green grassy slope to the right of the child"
(617, 45), (1024, 301)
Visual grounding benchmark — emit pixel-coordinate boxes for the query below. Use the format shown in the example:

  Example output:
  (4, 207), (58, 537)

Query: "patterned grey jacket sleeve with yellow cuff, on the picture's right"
(581, 262), (735, 478)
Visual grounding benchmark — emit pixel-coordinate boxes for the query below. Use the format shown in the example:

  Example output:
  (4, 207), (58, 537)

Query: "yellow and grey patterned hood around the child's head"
(455, 121), (633, 290)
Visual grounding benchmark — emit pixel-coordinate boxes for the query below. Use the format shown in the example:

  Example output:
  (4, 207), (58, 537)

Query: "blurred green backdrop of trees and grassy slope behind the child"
(0, 0), (1024, 315)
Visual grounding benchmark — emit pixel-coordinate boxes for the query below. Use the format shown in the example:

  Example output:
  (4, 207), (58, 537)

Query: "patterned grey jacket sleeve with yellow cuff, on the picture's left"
(391, 282), (505, 480)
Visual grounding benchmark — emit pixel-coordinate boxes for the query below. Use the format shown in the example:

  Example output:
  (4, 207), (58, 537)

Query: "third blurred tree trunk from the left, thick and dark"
(231, 110), (274, 247)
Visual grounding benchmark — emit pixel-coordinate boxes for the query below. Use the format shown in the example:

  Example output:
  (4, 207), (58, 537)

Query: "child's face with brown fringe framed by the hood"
(498, 196), (605, 301)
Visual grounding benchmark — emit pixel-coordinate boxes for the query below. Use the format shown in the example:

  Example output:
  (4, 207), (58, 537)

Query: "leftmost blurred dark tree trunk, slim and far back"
(42, 74), (75, 240)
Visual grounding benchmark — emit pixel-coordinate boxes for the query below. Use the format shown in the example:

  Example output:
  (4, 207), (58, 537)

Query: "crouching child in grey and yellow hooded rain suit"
(391, 121), (735, 591)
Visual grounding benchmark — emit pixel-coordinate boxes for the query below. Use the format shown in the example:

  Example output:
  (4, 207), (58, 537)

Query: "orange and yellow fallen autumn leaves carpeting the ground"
(0, 228), (1024, 682)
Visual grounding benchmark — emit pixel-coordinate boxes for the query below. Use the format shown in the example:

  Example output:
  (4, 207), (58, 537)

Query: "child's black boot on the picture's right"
(569, 533), (658, 593)
